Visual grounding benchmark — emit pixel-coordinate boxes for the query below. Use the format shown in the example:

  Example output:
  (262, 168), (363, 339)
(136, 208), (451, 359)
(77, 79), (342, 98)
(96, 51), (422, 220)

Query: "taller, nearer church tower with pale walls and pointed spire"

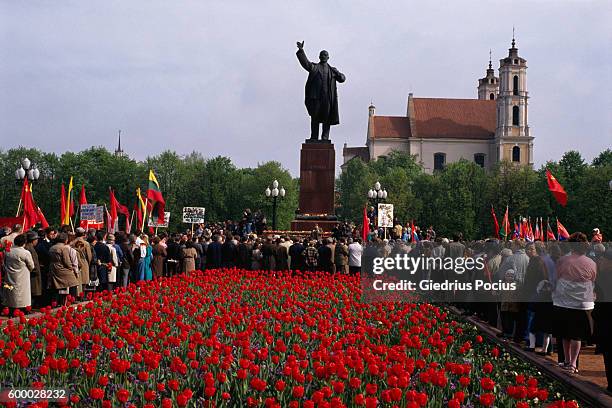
(495, 33), (533, 166)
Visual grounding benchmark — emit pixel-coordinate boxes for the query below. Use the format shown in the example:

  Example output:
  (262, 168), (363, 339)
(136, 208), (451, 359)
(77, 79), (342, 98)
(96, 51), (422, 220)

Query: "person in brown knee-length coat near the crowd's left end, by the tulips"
(49, 232), (81, 305)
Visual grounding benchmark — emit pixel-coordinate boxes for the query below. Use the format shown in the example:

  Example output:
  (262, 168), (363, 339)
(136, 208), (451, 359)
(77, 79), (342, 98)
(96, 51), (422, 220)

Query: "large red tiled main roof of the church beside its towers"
(414, 98), (497, 139)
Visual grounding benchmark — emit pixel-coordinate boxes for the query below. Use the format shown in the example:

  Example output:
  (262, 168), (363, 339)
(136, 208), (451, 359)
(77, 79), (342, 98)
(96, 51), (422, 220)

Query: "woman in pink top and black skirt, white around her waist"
(552, 232), (597, 373)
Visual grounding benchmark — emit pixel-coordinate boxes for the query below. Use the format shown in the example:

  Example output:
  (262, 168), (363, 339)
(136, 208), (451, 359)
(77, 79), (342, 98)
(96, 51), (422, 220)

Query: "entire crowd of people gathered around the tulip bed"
(0, 218), (612, 390)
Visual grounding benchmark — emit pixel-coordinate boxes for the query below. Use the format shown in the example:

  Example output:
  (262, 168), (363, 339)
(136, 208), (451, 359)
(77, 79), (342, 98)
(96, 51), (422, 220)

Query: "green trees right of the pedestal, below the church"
(337, 149), (612, 239)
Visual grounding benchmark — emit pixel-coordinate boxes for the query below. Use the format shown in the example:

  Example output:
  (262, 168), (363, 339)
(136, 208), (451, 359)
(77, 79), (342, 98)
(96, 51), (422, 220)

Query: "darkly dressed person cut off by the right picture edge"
(593, 247), (612, 392)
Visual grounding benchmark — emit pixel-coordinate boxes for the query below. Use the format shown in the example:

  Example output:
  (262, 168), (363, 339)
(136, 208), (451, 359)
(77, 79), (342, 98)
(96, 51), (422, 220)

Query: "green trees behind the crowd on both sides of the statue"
(0, 147), (612, 239)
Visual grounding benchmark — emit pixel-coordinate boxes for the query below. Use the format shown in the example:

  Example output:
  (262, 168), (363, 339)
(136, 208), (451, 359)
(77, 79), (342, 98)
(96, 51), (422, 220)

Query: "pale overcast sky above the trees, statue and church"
(0, 0), (612, 176)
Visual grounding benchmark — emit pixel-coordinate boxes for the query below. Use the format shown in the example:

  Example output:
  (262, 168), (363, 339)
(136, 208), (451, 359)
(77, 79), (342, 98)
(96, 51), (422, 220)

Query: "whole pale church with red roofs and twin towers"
(342, 38), (533, 173)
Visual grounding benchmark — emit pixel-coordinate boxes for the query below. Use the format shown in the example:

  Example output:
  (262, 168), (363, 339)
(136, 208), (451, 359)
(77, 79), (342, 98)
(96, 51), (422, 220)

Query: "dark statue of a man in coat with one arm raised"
(297, 41), (346, 141)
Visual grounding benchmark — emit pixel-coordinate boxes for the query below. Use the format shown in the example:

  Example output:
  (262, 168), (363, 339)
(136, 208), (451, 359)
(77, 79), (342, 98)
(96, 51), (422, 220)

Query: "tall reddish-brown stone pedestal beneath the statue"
(291, 141), (337, 231)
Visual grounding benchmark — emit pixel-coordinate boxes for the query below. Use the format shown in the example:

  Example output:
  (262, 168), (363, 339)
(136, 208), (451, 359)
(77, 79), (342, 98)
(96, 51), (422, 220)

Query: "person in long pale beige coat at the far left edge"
(3, 234), (35, 315)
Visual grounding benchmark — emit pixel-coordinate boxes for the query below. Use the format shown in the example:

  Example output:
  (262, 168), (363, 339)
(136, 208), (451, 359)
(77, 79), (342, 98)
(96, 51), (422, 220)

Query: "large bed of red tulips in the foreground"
(0, 270), (577, 407)
